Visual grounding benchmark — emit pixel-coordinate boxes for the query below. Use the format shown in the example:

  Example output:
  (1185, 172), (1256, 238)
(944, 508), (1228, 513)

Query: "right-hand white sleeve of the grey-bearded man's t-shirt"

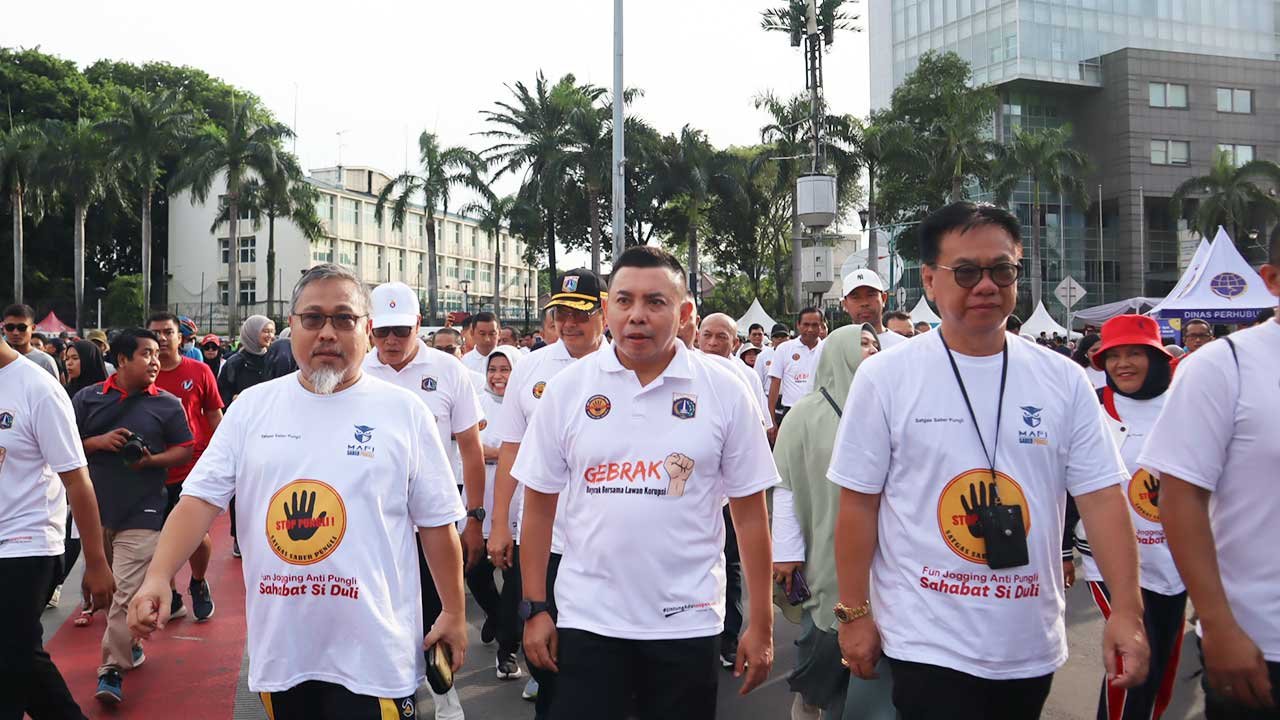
(408, 402), (466, 528)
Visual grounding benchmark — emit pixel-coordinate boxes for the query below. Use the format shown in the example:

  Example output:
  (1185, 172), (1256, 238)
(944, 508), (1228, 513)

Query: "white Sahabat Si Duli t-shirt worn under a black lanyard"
(827, 333), (1125, 680)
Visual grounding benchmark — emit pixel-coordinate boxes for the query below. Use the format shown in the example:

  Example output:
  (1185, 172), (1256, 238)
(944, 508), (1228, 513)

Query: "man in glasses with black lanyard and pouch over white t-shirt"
(827, 202), (1148, 720)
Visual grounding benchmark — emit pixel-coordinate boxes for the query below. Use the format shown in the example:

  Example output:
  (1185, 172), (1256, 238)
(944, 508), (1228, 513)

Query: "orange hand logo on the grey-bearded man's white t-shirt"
(266, 480), (347, 565)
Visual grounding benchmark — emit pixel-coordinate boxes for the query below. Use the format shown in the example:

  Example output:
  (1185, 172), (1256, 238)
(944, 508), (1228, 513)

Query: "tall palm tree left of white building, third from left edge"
(97, 90), (192, 315)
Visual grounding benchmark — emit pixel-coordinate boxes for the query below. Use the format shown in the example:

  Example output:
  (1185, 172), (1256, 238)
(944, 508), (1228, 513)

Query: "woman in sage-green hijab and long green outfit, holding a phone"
(773, 324), (895, 720)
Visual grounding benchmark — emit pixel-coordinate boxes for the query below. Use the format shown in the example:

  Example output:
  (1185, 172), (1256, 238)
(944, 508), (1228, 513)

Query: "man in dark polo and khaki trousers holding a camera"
(72, 328), (192, 705)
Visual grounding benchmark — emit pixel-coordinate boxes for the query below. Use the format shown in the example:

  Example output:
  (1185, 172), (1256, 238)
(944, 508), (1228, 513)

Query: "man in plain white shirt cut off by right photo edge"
(1138, 236), (1280, 720)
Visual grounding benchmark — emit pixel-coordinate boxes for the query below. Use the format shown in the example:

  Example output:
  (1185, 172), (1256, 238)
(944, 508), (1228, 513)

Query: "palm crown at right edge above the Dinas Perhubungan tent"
(1169, 151), (1280, 242)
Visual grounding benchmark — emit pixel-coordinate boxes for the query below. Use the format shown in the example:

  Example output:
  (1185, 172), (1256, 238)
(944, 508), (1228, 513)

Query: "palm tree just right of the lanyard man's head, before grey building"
(995, 124), (1089, 307)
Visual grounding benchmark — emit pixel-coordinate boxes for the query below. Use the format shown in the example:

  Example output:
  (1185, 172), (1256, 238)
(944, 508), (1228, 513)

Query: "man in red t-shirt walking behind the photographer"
(147, 313), (223, 623)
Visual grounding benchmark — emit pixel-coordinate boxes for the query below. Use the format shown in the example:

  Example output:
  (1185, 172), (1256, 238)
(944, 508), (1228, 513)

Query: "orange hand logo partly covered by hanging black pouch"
(938, 468), (1032, 565)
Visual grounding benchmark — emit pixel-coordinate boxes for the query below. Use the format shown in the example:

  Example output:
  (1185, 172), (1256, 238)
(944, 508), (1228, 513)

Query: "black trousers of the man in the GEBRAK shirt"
(552, 629), (719, 720)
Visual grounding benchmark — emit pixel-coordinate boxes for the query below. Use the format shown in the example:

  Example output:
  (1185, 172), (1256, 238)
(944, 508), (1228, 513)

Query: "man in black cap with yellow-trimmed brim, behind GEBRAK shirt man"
(489, 268), (608, 720)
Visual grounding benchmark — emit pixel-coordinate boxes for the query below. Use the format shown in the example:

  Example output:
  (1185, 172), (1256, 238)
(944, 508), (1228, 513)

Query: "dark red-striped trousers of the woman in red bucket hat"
(1089, 580), (1187, 720)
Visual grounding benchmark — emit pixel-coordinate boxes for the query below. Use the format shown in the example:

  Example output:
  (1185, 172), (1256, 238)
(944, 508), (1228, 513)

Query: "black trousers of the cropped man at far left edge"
(0, 556), (84, 720)
